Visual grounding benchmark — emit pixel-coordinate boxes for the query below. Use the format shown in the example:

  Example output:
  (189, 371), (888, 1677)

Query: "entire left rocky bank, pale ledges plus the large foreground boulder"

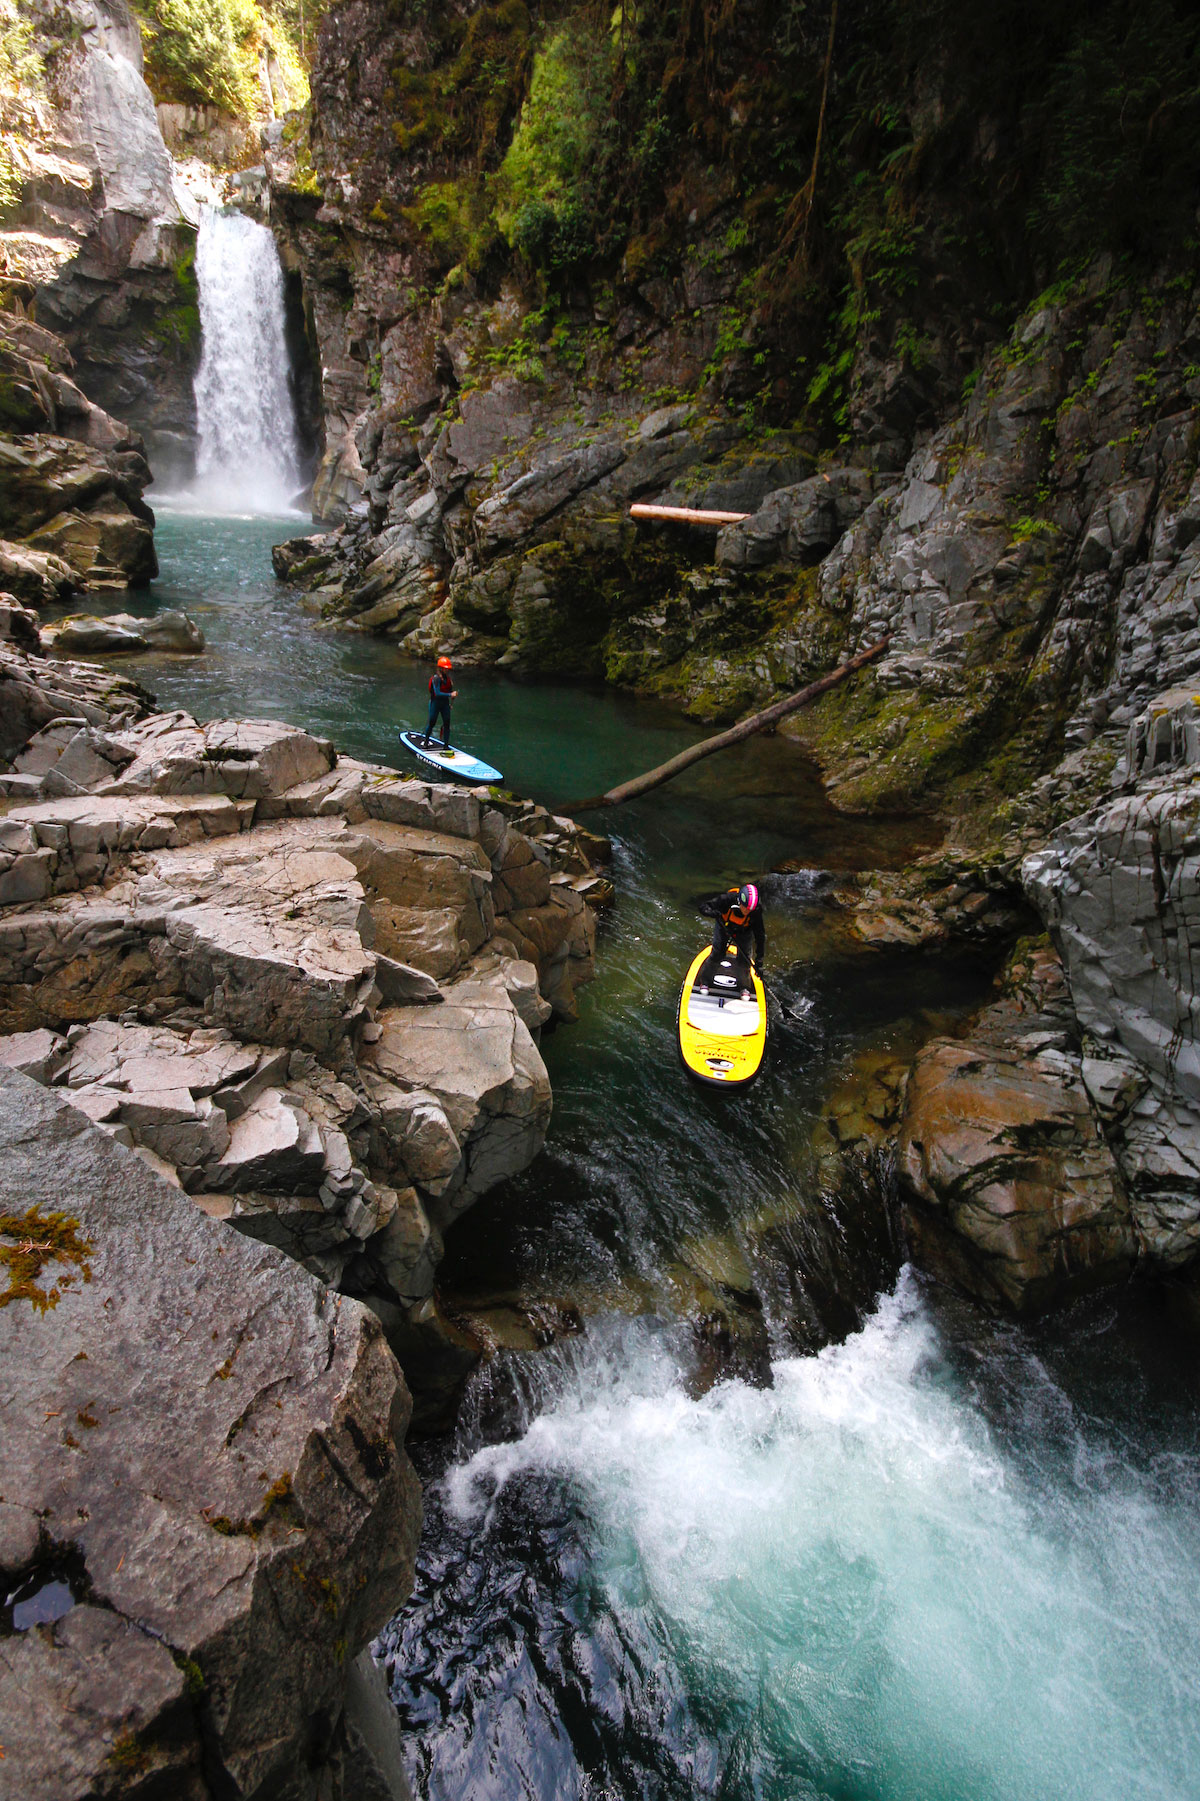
(0, 633), (607, 1797)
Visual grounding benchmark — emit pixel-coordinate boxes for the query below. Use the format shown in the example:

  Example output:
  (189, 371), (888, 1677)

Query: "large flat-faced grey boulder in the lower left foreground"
(0, 1072), (420, 1801)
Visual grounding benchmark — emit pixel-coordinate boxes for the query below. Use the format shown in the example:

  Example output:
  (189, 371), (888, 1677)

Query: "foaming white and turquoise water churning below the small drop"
(445, 1279), (1200, 1801)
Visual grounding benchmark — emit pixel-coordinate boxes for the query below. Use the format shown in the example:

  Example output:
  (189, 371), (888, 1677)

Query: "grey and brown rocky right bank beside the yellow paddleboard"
(785, 688), (1200, 1317)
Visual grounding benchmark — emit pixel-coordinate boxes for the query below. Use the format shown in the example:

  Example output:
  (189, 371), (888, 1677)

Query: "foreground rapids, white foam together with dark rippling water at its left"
(384, 1273), (1200, 1801)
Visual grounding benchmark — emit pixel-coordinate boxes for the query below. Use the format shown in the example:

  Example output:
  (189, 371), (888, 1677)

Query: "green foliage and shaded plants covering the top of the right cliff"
(380, 0), (1200, 441)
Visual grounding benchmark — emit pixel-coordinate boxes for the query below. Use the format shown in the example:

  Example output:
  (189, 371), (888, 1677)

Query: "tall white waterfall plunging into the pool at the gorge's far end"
(193, 207), (301, 513)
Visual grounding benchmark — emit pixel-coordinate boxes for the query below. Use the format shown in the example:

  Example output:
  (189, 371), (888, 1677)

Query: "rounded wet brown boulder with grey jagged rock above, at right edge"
(901, 692), (1200, 1309)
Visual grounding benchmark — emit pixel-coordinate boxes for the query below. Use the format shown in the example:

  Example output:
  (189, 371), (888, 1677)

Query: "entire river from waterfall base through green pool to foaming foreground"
(90, 513), (1200, 1801)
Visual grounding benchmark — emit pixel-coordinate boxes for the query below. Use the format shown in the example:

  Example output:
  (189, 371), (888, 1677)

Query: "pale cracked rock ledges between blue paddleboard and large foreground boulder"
(0, 650), (607, 1417)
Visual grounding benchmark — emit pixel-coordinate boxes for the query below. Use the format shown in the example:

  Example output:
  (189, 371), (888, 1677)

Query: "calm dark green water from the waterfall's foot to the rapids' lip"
(100, 513), (982, 1309)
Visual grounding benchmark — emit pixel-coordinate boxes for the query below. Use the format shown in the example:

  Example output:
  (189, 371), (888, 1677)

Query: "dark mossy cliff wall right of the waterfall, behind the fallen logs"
(268, 0), (1200, 805)
